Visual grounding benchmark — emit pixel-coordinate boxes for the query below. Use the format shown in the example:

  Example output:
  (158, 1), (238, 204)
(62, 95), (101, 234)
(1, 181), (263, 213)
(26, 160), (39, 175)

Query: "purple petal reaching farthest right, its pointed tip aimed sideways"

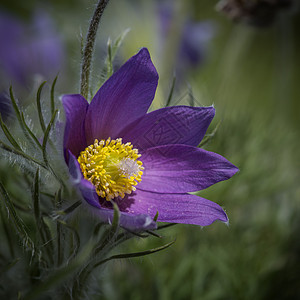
(137, 145), (238, 193)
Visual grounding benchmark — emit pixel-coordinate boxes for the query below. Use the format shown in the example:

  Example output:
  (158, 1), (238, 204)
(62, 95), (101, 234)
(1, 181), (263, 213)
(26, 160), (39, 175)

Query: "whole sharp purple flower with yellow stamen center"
(63, 48), (238, 230)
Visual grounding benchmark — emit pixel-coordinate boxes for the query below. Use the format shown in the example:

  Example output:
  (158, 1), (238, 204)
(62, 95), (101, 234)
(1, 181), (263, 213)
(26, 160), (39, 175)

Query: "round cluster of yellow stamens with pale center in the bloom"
(78, 138), (144, 201)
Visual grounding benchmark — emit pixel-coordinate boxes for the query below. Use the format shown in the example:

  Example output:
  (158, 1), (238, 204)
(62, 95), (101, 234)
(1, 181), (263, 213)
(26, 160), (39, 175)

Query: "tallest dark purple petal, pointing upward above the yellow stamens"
(85, 48), (158, 144)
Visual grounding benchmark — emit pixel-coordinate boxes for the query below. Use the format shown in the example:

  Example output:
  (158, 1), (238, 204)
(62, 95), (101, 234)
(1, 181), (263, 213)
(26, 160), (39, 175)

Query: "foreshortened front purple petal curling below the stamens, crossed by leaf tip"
(68, 151), (156, 231)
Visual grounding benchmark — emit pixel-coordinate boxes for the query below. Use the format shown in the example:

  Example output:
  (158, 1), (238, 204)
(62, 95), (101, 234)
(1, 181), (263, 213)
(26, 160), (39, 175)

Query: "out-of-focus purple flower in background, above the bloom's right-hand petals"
(158, 1), (215, 73)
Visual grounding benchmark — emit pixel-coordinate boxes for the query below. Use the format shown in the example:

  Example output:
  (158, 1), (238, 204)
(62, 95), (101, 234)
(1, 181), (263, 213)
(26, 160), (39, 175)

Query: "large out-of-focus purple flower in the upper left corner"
(0, 11), (64, 88)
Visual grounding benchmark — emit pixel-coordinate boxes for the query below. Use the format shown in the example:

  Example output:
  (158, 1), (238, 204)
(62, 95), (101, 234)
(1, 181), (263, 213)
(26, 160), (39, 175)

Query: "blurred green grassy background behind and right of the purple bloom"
(1, 0), (300, 300)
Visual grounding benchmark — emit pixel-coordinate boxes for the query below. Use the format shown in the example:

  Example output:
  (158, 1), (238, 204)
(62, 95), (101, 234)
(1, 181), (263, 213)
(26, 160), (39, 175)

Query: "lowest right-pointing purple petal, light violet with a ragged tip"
(127, 190), (228, 226)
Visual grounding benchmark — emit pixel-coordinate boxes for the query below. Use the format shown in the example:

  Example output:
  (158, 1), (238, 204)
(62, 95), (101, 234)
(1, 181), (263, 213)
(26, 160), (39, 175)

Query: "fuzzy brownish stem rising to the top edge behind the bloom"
(80, 0), (109, 99)
